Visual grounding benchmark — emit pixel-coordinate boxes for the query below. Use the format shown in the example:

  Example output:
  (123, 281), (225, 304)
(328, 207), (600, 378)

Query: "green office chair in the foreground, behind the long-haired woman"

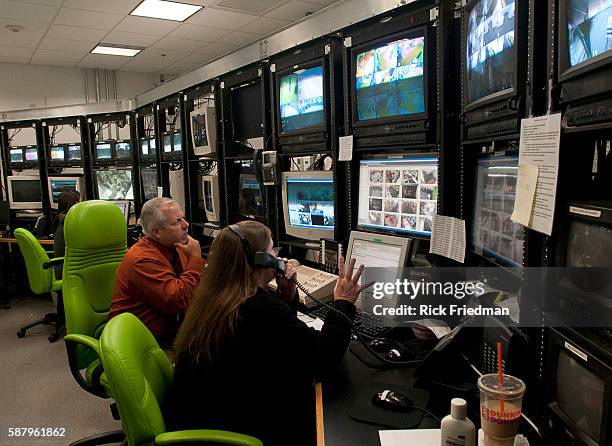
(100, 313), (263, 446)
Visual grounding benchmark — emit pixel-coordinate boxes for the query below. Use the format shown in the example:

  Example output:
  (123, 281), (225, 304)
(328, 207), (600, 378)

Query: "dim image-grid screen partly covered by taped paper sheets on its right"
(473, 157), (524, 266)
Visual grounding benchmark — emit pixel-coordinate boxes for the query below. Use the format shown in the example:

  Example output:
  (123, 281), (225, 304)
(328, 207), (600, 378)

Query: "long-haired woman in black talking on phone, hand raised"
(164, 221), (363, 446)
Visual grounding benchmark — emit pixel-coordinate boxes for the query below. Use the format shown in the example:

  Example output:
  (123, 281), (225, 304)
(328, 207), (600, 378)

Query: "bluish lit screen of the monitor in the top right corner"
(567, 0), (612, 67)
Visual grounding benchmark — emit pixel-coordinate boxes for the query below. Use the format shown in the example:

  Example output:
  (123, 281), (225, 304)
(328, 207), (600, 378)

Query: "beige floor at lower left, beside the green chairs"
(0, 297), (121, 446)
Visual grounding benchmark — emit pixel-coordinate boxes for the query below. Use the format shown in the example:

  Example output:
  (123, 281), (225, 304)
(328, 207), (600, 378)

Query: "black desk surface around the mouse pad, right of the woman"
(319, 344), (440, 446)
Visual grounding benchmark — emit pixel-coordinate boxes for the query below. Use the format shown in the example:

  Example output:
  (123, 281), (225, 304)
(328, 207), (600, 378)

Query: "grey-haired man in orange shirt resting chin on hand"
(108, 197), (205, 346)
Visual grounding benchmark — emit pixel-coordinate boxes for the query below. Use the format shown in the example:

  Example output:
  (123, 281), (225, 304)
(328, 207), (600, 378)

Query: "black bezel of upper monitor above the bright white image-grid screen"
(349, 25), (433, 128)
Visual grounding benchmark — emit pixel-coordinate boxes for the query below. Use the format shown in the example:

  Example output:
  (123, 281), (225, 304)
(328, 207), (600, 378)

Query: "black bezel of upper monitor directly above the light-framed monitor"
(274, 57), (330, 138)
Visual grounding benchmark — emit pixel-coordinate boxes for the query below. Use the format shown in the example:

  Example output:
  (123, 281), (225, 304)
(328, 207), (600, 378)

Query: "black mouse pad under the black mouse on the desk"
(349, 383), (429, 429)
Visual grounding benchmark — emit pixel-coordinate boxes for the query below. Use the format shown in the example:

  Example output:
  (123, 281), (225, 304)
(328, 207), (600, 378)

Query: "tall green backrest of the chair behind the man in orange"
(62, 200), (127, 369)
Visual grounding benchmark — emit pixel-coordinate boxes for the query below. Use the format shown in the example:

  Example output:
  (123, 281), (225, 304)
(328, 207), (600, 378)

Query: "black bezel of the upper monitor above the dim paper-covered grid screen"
(461, 0), (527, 112)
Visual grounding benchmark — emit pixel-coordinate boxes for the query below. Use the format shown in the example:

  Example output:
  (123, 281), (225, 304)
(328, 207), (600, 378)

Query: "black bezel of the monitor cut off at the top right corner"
(557, 0), (612, 82)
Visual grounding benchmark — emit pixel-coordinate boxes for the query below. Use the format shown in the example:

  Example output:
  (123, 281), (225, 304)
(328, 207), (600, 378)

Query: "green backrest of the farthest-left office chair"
(15, 228), (61, 294)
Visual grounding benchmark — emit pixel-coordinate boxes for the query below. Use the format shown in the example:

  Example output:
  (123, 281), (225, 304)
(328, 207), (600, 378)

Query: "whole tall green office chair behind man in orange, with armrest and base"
(62, 200), (127, 445)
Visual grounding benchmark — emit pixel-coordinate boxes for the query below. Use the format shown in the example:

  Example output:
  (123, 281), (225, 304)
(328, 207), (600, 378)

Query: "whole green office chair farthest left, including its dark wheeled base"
(15, 228), (64, 342)
